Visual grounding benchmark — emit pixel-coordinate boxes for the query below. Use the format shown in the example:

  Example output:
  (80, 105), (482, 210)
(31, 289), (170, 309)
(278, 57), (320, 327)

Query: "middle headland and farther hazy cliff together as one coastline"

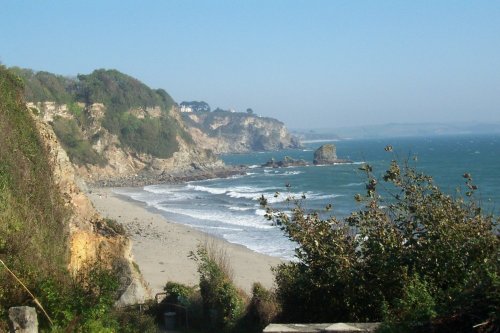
(16, 68), (300, 175)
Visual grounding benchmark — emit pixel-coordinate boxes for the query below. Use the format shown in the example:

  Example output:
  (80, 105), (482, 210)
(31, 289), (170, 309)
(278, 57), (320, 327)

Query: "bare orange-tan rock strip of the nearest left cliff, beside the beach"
(34, 113), (150, 305)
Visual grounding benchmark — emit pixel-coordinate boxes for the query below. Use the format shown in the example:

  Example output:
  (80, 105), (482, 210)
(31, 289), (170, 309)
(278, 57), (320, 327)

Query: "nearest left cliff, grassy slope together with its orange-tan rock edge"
(0, 66), (147, 331)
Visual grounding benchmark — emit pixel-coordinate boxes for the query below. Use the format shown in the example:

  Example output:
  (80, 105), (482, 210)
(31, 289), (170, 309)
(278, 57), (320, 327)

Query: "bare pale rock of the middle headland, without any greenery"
(28, 102), (223, 182)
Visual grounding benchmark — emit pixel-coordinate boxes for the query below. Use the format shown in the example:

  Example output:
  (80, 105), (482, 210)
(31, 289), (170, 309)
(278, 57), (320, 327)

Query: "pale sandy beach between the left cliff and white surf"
(89, 188), (282, 295)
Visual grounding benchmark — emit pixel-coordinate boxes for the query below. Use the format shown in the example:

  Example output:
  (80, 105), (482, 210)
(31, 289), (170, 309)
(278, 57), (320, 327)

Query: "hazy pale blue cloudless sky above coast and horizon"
(0, 0), (500, 128)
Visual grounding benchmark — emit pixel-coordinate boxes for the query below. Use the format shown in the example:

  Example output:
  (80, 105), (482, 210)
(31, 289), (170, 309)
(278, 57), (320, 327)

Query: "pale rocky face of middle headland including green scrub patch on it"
(28, 102), (223, 182)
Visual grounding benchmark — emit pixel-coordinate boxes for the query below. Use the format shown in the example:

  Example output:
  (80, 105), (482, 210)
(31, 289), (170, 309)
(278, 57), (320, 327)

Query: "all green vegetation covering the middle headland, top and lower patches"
(13, 68), (192, 159)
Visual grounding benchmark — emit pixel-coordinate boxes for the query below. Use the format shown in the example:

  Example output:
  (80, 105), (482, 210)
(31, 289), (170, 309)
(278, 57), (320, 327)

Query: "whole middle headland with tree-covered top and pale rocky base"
(16, 69), (223, 182)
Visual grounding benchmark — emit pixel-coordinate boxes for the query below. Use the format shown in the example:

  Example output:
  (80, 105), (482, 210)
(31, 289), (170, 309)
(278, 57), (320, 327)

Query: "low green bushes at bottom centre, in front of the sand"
(155, 243), (278, 333)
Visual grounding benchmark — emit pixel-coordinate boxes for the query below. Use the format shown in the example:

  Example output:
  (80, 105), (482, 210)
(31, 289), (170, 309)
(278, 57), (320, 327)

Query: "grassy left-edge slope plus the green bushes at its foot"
(0, 66), (158, 333)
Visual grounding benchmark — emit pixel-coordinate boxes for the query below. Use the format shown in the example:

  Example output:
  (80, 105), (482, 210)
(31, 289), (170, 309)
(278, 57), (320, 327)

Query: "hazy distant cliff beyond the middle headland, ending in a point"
(183, 111), (300, 154)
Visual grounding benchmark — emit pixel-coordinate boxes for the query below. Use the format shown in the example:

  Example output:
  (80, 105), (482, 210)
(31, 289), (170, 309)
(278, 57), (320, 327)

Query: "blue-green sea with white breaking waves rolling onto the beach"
(114, 134), (500, 260)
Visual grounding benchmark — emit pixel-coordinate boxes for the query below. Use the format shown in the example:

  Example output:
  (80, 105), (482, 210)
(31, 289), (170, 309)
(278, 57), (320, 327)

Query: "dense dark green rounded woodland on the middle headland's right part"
(77, 69), (192, 158)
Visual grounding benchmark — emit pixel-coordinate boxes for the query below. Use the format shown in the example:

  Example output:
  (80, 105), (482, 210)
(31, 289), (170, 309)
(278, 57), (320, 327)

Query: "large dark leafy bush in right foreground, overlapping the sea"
(262, 154), (500, 332)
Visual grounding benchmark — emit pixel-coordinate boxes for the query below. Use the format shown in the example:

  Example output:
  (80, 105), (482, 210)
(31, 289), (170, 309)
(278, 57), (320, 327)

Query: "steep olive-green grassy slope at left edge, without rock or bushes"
(0, 67), (68, 331)
